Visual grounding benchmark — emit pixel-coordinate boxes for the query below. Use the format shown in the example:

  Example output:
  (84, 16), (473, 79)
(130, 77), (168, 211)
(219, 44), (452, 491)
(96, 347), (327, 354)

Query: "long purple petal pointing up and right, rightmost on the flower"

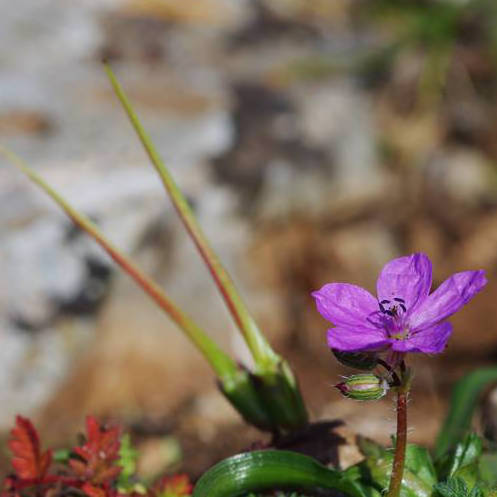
(409, 271), (487, 330)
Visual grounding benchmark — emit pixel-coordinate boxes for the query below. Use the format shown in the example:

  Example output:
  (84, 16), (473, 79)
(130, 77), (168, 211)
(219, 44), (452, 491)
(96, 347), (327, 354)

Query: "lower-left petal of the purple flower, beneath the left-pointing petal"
(328, 326), (391, 352)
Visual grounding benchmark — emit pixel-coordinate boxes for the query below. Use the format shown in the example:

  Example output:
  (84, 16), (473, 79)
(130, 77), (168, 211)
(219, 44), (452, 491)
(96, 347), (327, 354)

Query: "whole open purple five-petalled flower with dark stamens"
(312, 254), (487, 354)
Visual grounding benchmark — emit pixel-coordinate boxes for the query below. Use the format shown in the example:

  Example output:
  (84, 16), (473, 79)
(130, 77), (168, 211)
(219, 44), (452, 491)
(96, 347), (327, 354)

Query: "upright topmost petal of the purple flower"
(376, 253), (432, 314)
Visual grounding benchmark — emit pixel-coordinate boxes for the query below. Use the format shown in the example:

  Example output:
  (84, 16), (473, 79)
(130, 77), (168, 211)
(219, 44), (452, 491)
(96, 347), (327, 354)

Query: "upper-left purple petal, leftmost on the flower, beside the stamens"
(312, 283), (378, 328)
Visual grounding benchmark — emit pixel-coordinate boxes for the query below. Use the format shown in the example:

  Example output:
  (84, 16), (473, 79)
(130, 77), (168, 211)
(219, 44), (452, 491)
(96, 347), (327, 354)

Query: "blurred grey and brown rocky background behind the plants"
(0, 0), (497, 476)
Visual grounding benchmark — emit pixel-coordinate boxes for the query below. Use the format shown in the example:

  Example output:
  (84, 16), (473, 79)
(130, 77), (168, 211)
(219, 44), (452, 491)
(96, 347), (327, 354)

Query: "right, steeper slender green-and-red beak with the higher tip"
(104, 64), (280, 370)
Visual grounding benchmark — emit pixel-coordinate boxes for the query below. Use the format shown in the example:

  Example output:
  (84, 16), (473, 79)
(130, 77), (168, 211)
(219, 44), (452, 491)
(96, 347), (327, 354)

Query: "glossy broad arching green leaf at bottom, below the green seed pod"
(193, 450), (371, 497)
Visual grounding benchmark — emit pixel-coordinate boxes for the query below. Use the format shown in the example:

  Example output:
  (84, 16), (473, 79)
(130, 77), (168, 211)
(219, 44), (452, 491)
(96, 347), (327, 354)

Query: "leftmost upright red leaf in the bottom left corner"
(9, 416), (52, 480)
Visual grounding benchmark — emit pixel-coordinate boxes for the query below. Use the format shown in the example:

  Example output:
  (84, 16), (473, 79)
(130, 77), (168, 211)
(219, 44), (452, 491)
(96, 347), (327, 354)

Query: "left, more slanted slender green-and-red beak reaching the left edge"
(0, 146), (239, 381)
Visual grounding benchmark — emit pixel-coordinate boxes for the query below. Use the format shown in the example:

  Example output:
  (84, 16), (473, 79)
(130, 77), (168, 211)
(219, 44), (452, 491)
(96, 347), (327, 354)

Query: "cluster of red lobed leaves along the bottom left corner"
(0, 416), (192, 497)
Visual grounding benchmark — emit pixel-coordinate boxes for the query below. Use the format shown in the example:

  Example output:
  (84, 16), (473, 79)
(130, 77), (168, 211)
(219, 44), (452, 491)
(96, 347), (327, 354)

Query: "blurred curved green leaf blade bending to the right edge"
(435, 367), (497, 459)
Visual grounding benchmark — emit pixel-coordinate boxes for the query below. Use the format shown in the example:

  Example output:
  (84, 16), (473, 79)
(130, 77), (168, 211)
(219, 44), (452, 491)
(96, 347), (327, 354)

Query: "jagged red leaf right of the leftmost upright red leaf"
(69, 416), (121, 482)
